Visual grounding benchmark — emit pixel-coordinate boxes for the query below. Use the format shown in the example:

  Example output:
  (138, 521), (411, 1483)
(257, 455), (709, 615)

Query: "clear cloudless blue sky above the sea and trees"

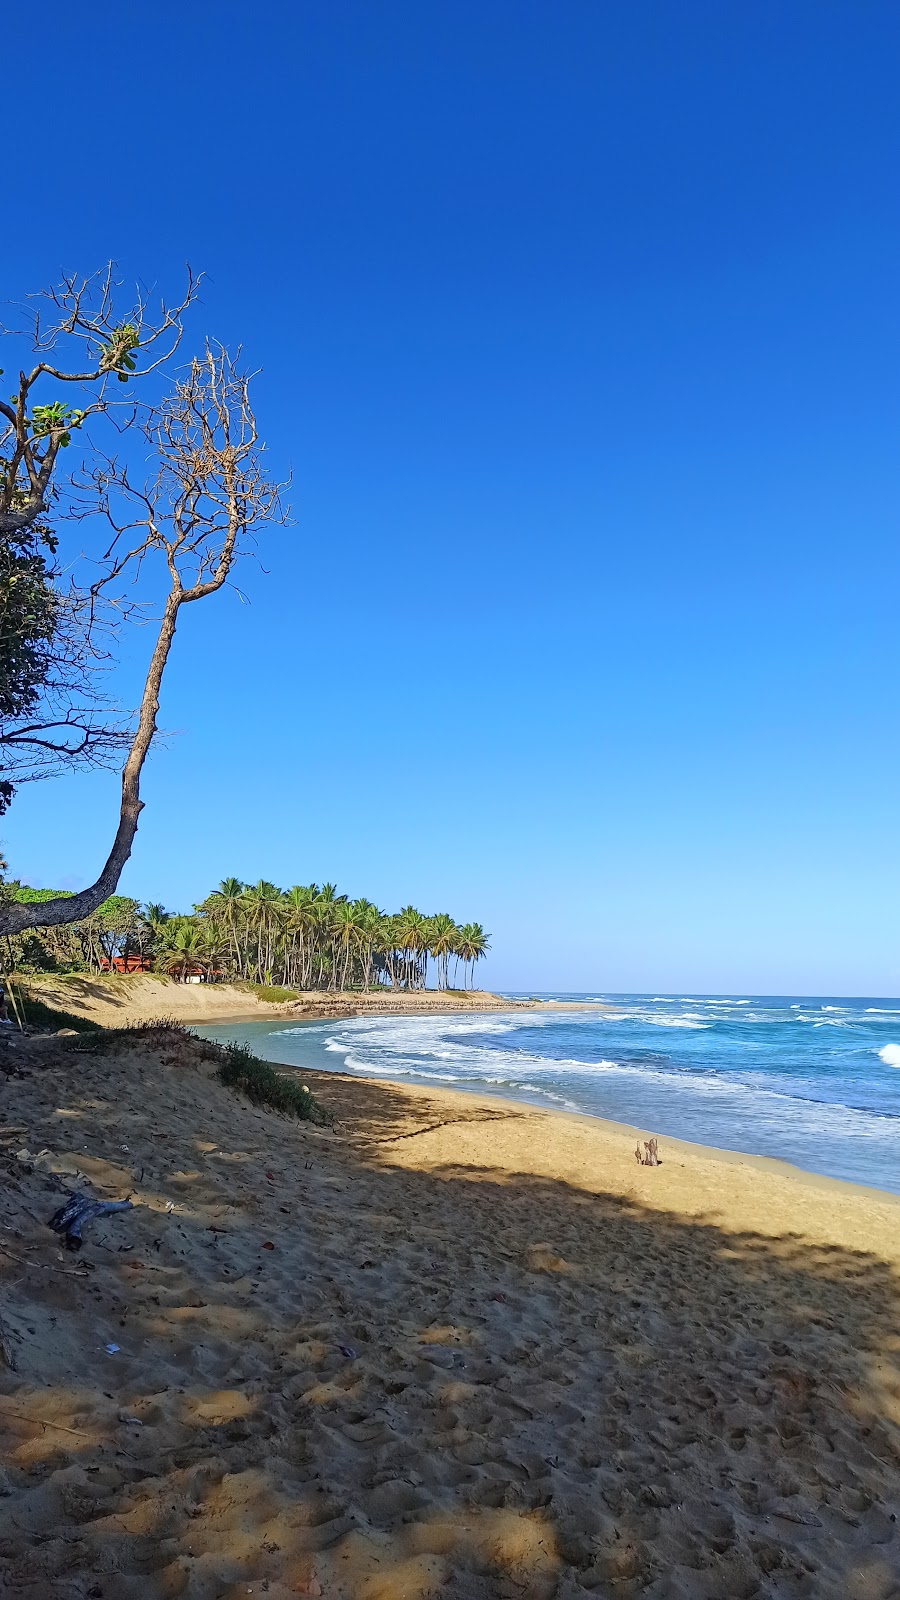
(0, 0), (900, 995)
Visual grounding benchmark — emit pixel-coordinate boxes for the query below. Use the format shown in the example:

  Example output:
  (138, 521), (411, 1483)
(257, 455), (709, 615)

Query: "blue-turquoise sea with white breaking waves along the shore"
(200, 994), (900, 1194)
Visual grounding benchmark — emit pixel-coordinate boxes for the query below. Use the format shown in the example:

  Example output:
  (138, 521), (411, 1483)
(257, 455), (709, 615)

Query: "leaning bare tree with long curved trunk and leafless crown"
(0, 344), (283, 934)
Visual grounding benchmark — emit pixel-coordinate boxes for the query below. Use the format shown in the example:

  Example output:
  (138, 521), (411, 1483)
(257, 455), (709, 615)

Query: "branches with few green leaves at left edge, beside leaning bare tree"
(0, 264), (199, 811)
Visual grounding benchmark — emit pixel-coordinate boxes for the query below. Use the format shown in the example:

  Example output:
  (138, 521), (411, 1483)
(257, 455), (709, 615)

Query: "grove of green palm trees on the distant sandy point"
(2, 877), (490, 990)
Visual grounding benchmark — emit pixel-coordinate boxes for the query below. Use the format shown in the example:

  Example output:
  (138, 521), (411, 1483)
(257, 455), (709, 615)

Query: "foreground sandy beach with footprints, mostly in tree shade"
(0, 1038), (900, 1600)
